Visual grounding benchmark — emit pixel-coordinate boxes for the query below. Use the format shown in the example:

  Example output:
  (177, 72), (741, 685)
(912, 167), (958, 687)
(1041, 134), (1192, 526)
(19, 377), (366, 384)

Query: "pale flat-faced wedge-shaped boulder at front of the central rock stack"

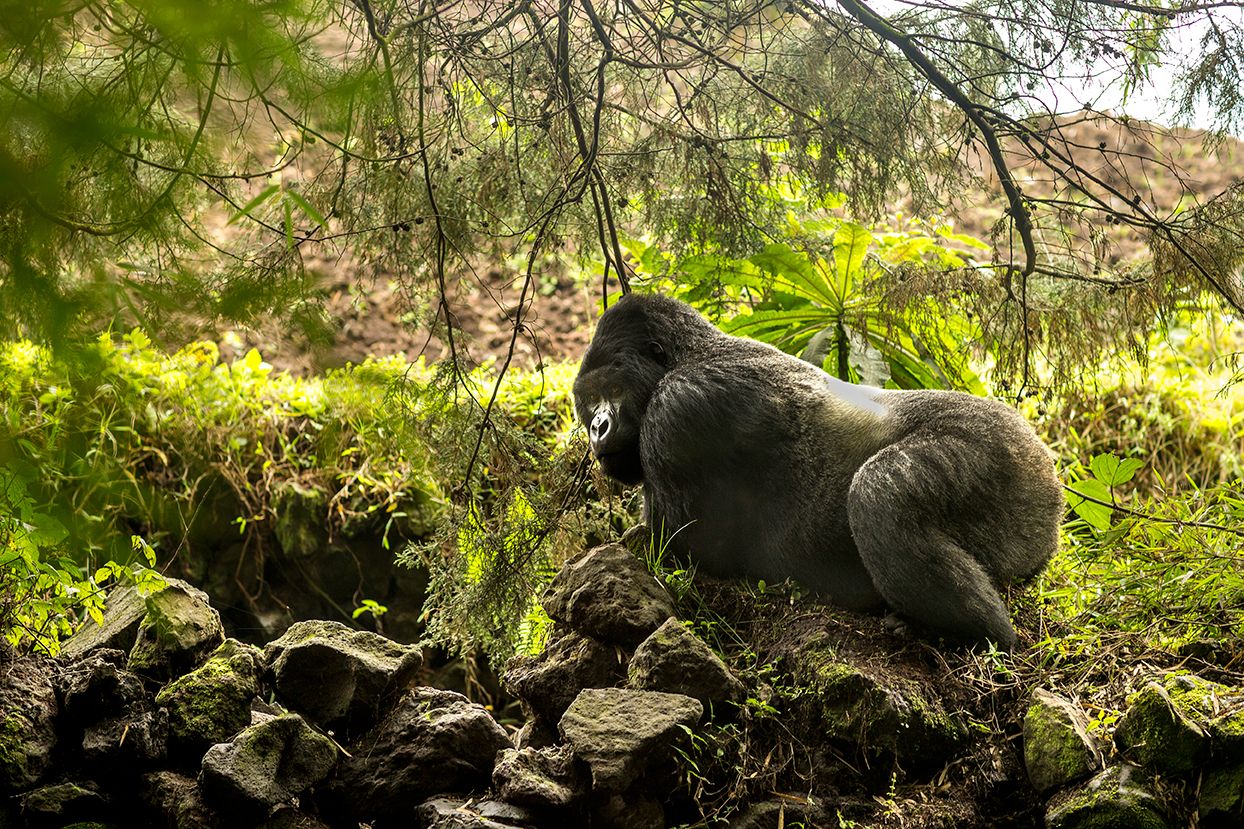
(557, 688), (704, 794)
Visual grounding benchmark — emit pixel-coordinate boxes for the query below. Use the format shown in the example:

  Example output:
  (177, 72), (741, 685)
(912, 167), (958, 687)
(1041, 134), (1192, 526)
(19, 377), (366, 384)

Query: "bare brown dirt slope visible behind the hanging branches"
(221, 118), (1244, 373)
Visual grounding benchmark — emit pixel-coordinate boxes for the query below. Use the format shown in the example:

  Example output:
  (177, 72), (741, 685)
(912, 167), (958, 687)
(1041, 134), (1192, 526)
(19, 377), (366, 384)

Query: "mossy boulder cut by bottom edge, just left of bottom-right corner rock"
(1045, 764), (1168, 829)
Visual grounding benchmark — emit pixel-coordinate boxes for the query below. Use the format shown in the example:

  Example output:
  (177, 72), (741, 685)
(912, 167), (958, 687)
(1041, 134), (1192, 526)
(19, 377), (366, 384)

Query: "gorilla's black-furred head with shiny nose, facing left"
(575, 294), (719, 484)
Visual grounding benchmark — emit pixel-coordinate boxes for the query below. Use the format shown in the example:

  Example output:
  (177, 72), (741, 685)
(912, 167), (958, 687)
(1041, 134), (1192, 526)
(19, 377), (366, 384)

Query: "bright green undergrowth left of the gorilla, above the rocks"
(0, 331), (587, 652)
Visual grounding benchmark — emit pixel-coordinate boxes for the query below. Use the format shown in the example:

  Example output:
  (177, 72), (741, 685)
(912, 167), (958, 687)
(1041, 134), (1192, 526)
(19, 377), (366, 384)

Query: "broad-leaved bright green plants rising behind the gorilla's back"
(631, 212), (988, 393)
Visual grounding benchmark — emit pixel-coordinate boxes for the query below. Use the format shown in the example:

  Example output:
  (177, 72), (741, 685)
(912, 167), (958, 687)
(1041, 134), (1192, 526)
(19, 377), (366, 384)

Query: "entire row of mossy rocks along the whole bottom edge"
(0, 545), (1244, 829)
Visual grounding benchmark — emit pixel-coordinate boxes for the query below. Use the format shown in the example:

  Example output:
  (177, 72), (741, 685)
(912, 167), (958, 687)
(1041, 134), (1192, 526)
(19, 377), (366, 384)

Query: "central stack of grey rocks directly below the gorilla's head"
(493, 544), (744, 829)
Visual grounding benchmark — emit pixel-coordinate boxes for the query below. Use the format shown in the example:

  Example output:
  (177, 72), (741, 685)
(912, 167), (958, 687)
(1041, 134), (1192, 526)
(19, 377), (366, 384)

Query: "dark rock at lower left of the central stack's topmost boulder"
(503, 632), (626, 723)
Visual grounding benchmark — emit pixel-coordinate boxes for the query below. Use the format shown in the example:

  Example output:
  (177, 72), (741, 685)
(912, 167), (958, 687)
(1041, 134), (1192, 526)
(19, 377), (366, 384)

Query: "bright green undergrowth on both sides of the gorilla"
(0, 313), (1244, 691)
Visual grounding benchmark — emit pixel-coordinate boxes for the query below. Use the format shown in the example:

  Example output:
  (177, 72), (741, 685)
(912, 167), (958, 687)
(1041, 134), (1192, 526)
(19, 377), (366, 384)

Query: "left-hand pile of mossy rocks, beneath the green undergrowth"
(0, 580), (480, 829)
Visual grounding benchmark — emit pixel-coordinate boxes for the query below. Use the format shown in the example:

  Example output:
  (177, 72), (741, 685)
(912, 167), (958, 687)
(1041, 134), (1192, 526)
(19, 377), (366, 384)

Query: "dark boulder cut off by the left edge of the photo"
(0, 657), (60, 797)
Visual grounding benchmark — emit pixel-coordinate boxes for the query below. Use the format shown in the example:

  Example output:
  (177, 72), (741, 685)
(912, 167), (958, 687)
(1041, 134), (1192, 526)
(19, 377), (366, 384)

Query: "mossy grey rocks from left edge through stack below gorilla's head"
(0, 546), (743, 829)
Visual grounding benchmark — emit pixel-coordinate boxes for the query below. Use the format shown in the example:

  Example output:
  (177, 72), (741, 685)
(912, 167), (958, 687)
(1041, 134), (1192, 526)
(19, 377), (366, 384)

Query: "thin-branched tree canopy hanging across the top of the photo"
(0, 0), (1244, 376)
